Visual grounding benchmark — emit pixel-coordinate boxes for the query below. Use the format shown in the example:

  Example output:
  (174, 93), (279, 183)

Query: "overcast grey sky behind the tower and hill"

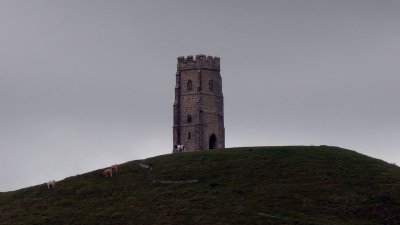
(0, 0), (400, 191)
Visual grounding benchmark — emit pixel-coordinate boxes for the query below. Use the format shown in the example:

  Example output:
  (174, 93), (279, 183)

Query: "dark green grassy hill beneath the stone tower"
(0, 146), (400, 225)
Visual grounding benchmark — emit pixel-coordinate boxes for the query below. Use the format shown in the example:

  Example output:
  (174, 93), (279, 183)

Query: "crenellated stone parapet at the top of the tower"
(178, 54), (220, 71)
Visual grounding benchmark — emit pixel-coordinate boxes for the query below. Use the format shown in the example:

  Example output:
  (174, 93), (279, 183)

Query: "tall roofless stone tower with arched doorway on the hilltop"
(173, 55), (225, 152)
